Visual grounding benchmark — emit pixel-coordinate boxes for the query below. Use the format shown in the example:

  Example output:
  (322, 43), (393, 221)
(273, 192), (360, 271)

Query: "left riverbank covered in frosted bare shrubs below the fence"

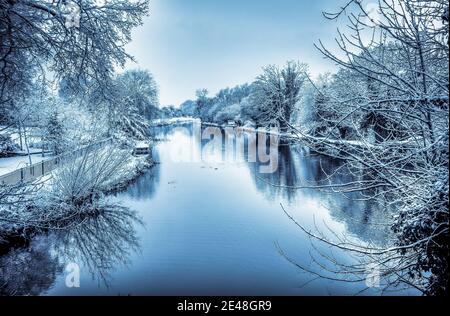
(0, 147), (154, 248)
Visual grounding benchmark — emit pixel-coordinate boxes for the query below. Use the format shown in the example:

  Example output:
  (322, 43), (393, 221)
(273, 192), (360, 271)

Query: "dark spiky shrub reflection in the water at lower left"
(0, 200), (143, 295)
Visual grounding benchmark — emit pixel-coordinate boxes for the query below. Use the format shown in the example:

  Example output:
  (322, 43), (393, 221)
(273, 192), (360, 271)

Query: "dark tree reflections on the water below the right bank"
(248, 142), (390, 244)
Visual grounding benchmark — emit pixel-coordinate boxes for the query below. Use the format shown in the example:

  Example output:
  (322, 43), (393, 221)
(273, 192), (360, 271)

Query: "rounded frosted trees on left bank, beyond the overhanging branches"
(59, 70), (161, 142)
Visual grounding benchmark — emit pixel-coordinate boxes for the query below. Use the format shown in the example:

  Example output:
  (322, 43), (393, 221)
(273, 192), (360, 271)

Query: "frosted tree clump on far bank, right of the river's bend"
(182, 61), (308, 129)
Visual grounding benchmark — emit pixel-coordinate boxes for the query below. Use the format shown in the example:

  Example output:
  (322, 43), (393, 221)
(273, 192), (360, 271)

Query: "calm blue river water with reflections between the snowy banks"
(0, 124), (404, 295)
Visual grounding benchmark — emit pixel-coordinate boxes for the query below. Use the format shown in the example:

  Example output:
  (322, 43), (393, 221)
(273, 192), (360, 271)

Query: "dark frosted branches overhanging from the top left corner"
(0, 0), (148, 103)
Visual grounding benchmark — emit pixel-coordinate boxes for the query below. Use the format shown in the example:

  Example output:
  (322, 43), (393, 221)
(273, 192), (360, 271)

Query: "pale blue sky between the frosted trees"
(127, 0), (345, 105)
